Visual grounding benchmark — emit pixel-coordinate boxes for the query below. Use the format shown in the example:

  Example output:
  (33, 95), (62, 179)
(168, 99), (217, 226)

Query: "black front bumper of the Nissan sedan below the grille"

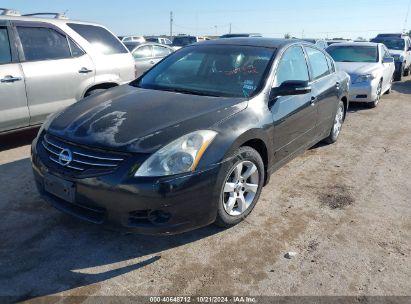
(32, 134), (226, 234)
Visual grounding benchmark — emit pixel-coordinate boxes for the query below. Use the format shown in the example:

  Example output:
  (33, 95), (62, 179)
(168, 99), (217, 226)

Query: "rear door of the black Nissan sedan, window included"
(304, 45), (340, 138)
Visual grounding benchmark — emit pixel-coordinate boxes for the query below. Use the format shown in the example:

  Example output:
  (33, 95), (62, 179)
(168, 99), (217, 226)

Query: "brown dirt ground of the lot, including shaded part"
(0, 78), (411, 300)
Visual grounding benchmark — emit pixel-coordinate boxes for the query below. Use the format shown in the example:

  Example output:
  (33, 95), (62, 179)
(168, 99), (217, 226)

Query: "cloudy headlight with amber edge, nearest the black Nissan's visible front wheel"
(134, 130), (217, 176)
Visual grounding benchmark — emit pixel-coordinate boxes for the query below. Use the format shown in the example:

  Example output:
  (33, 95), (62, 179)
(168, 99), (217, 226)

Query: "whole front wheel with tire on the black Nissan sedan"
(215, 147), (264, 228)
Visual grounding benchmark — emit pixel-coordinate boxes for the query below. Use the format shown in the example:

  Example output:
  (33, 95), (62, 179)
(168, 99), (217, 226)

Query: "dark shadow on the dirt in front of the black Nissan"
(0, 158), (222, 302)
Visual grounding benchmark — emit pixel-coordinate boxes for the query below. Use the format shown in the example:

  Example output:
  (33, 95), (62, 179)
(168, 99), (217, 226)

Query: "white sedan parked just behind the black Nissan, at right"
(327, 42), (395, 107)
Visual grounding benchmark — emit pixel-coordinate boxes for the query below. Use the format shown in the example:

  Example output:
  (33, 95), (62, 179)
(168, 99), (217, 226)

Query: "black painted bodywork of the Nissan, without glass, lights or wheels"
(32, 38), (349, 234)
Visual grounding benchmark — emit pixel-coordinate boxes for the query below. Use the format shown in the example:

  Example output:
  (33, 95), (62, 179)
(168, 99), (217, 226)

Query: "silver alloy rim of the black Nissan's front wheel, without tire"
(223, 161), (259, 216)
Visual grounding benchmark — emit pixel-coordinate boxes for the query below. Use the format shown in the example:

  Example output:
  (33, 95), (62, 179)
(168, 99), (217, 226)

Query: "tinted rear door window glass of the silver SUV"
(17, 26), (71, 61)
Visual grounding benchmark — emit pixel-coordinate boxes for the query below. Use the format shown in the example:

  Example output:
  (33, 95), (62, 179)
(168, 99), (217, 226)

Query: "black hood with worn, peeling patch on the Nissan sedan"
(46, 85), (248, 153)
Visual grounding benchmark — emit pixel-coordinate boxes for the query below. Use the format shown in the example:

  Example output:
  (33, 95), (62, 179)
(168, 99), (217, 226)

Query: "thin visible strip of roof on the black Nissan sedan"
(194, 37), (302, 49)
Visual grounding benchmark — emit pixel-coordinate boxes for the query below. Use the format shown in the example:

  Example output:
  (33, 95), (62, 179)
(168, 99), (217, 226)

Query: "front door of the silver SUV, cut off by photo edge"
(0, 21), (30, 132)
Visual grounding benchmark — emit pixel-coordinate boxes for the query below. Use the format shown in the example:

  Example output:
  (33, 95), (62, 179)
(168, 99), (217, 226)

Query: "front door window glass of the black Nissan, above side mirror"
(276, 46), (310, 86)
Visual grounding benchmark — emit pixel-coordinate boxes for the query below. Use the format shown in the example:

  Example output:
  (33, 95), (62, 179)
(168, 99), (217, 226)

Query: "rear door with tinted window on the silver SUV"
(14, 21), (95, 125)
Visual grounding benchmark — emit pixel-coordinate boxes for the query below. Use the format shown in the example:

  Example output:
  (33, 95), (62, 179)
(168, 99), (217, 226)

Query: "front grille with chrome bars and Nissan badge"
(41, 135), (124, 173)
